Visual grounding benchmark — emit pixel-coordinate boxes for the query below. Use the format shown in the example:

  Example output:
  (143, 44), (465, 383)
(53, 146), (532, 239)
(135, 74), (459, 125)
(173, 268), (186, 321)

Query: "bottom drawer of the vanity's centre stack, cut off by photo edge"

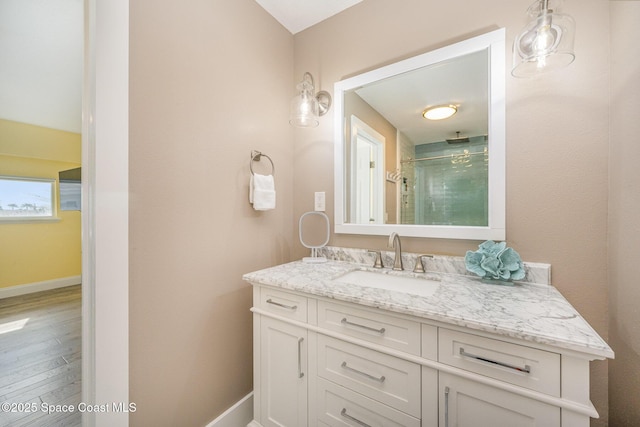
(317, 378), (420, 427)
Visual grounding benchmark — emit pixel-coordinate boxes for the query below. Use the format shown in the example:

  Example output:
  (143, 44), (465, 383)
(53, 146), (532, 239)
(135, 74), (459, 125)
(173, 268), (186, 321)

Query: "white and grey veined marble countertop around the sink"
(243, 261), (614, 359)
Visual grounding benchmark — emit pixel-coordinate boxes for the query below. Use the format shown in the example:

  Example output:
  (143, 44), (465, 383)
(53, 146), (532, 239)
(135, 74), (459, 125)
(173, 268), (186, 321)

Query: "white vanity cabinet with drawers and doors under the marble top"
(249, 282), (597, 427)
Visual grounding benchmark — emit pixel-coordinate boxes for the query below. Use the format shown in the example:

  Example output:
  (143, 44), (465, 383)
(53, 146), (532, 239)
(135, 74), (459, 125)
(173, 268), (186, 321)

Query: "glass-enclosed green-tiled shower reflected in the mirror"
(400, 132), (489, 226)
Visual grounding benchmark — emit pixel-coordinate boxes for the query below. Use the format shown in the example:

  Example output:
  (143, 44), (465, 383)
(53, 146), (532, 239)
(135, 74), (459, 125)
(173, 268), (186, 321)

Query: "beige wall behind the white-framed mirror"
(294, 0), (610, 425)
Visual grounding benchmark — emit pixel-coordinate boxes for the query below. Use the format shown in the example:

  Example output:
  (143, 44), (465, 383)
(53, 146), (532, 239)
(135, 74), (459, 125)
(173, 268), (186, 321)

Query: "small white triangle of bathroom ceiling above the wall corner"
(256, 0), (362, 34)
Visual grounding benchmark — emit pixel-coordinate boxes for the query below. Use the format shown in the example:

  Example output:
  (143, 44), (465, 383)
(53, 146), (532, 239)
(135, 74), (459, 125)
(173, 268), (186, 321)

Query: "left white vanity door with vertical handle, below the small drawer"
(260, 317), (307, 427)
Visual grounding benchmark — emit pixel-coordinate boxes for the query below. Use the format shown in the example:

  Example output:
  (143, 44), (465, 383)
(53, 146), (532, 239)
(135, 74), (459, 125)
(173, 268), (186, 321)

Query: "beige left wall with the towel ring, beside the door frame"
(129, 0), (294, 427)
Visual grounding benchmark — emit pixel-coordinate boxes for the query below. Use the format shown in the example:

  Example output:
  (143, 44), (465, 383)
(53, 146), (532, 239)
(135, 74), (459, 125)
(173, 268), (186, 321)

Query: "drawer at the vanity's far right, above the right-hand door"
(438, 328), (560, 396)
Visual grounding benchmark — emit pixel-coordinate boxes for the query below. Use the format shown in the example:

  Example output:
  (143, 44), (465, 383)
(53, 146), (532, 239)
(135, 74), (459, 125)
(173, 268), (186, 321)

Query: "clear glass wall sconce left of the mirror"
(289, 73), (331, 128)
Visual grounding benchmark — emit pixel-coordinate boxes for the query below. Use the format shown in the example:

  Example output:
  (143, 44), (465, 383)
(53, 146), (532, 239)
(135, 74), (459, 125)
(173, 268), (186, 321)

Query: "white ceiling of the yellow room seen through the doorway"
(0, 0), (83, 133)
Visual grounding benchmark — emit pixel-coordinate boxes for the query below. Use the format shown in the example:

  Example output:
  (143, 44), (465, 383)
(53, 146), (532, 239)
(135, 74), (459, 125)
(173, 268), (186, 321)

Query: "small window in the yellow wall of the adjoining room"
(0, 176), (56, 221)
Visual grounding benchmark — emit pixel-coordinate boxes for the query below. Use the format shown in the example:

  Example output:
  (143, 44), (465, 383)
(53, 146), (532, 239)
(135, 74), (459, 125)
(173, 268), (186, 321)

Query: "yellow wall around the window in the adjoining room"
(0, 120), (81, 288)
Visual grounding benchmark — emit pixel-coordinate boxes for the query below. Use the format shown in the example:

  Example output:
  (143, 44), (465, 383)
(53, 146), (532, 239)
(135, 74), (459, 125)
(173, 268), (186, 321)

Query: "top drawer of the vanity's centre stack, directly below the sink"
(318, 301), (420, 355)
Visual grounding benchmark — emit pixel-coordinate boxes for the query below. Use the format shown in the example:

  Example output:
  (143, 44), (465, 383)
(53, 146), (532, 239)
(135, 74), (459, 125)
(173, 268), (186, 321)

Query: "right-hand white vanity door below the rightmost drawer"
(439, 372), (560, 427)
